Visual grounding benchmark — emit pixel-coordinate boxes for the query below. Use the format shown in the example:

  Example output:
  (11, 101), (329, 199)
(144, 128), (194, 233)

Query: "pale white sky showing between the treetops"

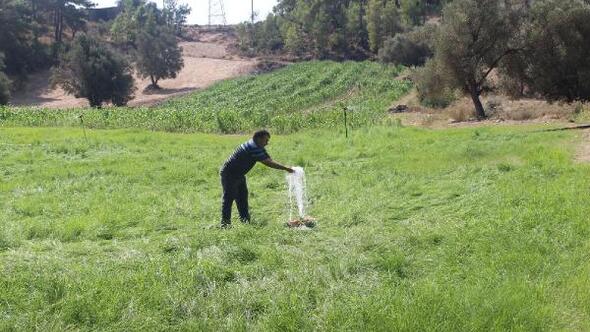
(93, 0), (277, 24)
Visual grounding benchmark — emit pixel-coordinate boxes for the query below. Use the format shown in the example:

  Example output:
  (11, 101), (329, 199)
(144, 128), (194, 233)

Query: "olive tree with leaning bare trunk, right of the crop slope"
(434, 0), (524, 119)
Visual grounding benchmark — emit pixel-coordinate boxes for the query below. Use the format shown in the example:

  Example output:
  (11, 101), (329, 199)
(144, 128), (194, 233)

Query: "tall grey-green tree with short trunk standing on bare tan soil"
(136, 3), (184, 88)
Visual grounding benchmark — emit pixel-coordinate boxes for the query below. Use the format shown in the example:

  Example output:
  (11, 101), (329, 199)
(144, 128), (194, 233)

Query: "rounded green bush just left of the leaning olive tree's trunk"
(413, 59), (457, 108)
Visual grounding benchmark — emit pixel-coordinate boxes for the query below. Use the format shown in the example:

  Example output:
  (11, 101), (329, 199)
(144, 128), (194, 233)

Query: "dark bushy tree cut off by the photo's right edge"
(524, 0), (590, 102)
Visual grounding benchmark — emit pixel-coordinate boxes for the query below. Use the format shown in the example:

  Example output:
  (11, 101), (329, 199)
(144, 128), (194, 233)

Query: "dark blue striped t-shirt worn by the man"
(220, 139), (270, 177)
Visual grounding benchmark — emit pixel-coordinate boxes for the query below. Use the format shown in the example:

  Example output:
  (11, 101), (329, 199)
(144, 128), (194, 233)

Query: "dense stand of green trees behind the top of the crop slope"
(238, 0), (450, 60)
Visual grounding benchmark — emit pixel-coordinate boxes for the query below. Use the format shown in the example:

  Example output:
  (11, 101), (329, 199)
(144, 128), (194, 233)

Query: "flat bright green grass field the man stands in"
(0, 127), (590, 331)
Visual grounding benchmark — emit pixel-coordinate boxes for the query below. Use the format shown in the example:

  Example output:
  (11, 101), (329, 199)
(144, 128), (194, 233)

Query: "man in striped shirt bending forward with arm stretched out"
(219, 130), (294, 227)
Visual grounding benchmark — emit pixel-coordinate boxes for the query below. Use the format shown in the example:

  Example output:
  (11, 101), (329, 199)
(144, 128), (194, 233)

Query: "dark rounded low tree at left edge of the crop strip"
(51, 34), (134, 107)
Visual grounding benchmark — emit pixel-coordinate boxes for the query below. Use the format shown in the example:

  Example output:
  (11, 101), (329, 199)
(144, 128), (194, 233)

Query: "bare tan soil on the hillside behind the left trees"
(11, 34), (256, 108)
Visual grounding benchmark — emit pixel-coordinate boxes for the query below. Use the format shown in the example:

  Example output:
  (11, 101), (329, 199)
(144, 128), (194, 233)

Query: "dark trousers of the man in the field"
(221, 174), (250, 225)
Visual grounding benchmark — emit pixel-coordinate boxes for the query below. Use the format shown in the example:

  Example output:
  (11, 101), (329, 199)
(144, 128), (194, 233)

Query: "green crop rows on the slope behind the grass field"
(0, 61), (410, 133)
